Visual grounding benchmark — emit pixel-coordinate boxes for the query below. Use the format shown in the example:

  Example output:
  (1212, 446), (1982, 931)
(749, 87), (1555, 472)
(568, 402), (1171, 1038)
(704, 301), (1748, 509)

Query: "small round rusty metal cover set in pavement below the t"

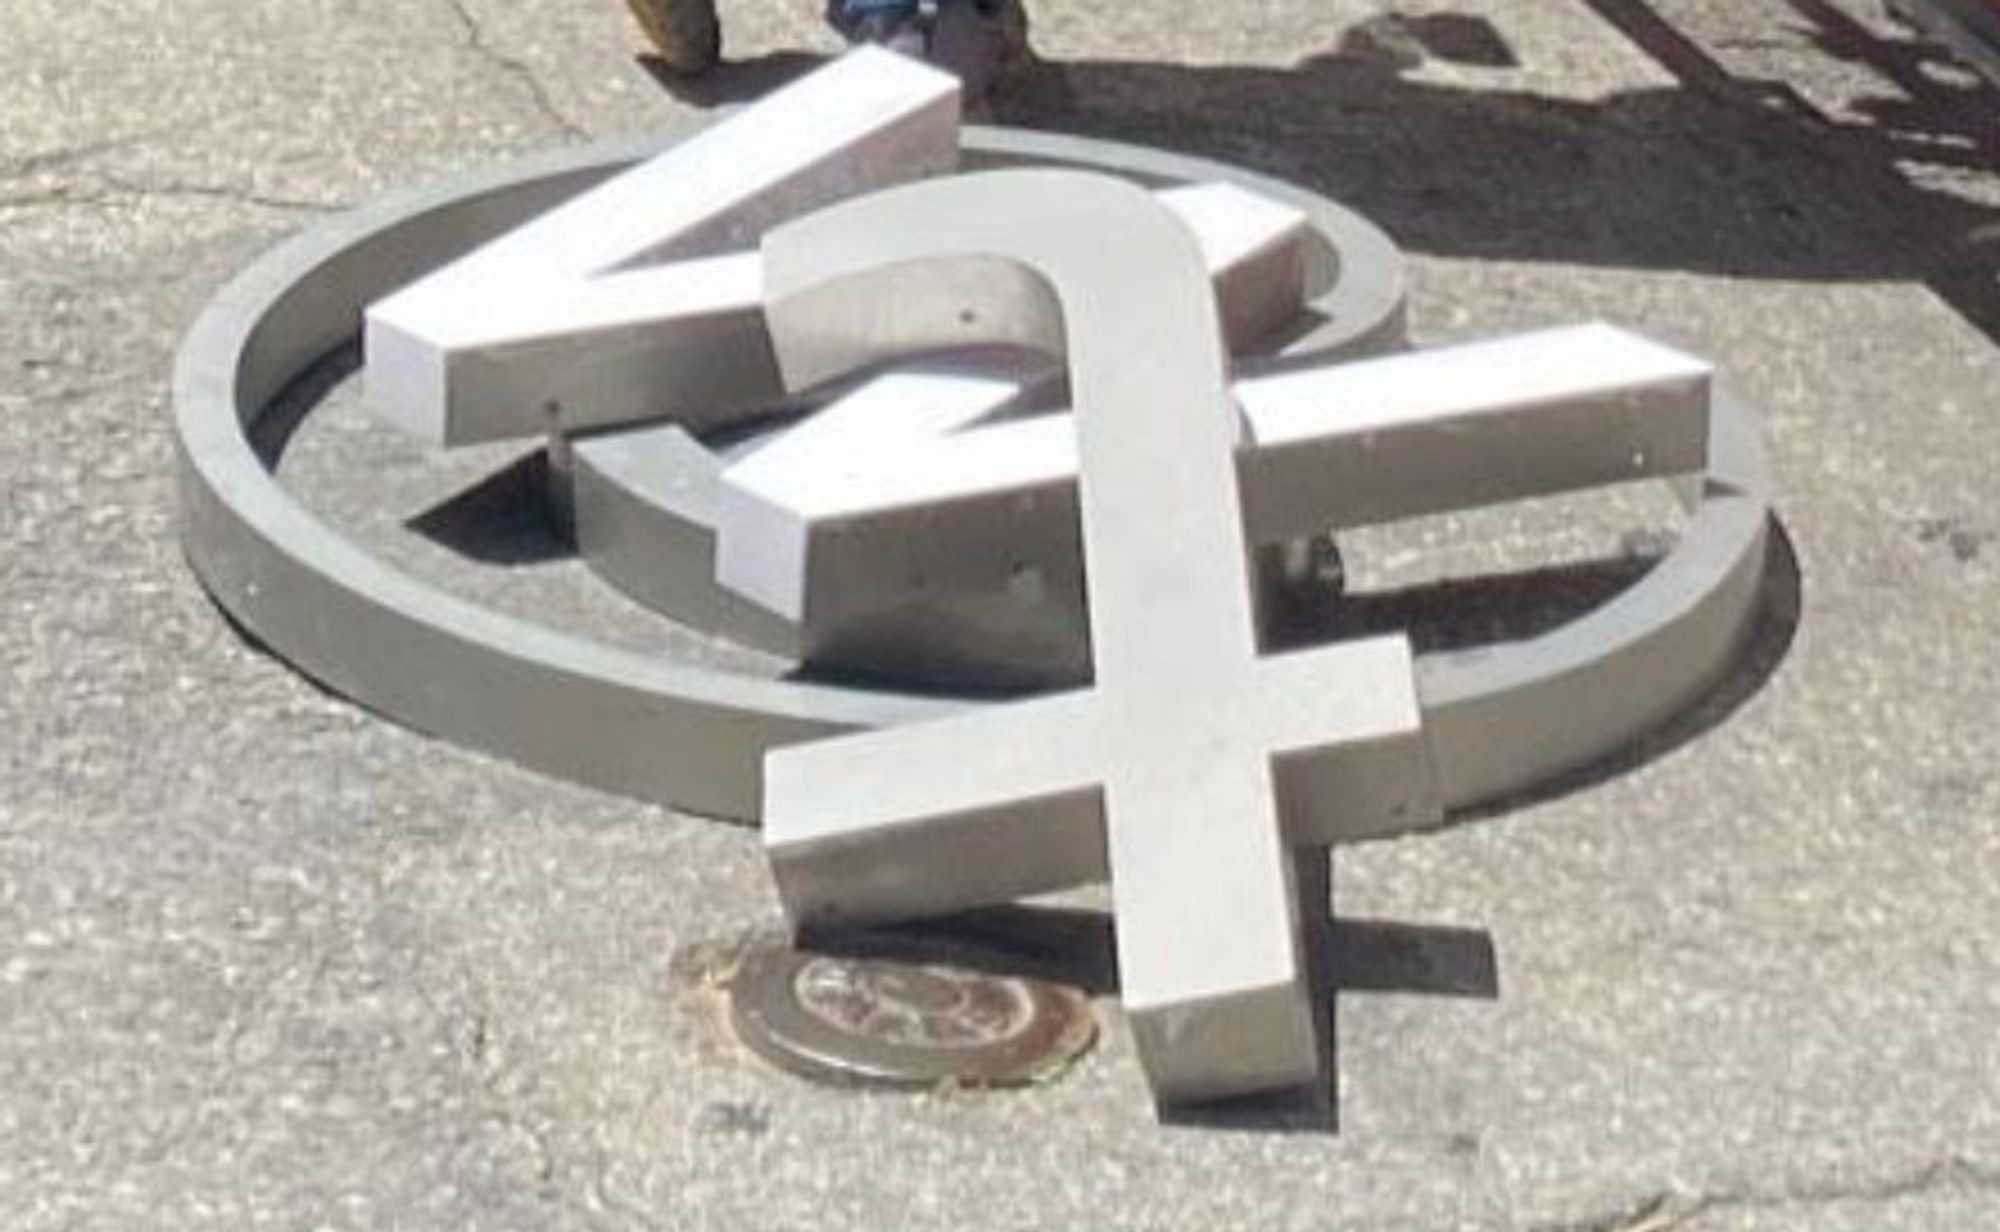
(730, 938), (1096, 1088)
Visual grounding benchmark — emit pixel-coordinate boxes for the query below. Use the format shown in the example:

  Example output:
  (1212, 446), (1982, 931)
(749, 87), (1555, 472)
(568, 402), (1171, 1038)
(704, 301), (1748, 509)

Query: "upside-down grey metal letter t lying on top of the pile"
(764, 170), (1438, 1102)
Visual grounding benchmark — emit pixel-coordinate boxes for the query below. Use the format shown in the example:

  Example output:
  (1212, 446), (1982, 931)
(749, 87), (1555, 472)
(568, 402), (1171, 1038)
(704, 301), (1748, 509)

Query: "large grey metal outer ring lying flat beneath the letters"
(174, 130), (1768, 818)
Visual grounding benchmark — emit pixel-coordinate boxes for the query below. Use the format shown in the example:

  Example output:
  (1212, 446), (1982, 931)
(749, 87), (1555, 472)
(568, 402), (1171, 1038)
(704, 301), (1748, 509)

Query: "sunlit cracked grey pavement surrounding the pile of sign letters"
(0, 0), (2000, 1232)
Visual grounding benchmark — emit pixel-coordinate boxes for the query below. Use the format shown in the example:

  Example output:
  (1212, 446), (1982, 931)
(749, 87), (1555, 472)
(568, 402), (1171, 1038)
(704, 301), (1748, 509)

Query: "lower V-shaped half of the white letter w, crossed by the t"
(716, 324), (1710, 624)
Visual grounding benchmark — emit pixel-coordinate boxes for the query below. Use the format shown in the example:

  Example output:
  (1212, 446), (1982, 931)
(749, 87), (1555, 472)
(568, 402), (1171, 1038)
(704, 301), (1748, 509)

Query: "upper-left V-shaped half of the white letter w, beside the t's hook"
(364, 48), (958, 444)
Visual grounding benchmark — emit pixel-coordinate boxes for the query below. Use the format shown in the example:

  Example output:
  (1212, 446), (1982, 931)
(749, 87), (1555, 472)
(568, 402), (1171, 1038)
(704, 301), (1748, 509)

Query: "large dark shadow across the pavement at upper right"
(654, 0), (2000, 342)
